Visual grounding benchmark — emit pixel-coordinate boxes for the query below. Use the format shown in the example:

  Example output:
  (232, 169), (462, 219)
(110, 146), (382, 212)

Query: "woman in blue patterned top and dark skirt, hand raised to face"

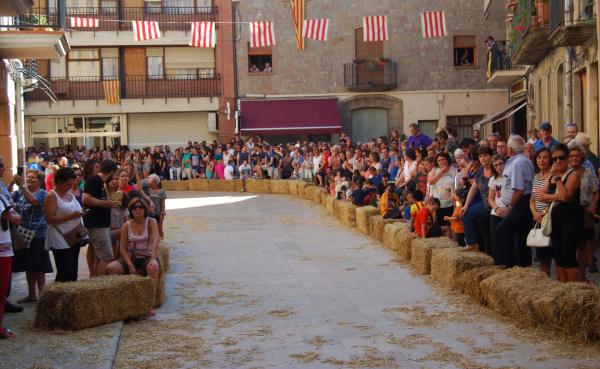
(12, 170), (53, 304)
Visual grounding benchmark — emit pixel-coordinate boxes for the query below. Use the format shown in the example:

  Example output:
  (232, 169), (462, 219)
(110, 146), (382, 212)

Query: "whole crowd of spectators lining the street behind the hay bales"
(0, 122), (600, 338)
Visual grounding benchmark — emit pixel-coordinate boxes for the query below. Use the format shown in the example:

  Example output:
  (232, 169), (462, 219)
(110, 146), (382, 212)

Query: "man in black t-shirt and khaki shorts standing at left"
(83, 160), (118, 275)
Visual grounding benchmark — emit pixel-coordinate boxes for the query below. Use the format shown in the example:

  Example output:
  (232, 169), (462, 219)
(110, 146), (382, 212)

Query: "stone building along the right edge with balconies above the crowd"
(489, 0), (600, 153)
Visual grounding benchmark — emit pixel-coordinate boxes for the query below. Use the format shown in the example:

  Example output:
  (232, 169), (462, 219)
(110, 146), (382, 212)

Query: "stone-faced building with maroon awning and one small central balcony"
(234, 0), (508, 142)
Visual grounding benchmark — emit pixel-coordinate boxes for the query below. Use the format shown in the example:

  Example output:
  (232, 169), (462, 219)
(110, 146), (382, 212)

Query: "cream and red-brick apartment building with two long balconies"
(25, 0), (235, 147)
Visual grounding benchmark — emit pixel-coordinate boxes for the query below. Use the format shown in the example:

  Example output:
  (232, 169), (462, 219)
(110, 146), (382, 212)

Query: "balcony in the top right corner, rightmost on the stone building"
(550, 0), (596, 46)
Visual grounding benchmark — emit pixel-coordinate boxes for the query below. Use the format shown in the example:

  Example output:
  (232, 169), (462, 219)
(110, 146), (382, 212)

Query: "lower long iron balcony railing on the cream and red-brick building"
(25, 74), (221, 101)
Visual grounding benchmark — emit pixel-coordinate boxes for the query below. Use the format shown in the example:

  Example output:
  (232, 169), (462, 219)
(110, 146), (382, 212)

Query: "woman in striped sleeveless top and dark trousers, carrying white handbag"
(529, 148), (552, 276)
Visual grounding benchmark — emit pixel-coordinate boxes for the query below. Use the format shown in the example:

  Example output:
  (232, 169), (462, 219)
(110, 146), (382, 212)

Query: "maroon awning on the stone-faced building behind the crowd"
(241, 99), (342, 135)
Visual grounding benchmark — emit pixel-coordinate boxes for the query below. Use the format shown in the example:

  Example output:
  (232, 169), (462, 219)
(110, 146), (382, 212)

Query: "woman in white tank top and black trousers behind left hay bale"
(44, 167), (84, 282)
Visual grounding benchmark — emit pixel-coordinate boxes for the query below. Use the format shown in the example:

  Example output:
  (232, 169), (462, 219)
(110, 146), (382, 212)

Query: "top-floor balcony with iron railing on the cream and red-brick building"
(37, 2), (218, 31)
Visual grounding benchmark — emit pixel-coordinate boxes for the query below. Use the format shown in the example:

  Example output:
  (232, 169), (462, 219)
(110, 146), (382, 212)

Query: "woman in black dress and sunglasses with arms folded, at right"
(539, 144), (583, 282)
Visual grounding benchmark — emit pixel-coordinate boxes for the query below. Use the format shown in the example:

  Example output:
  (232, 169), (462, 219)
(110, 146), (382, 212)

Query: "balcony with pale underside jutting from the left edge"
(0, 10), (70, 59)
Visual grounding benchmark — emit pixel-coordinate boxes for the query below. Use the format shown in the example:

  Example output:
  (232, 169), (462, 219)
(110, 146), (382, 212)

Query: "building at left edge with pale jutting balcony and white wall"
(0, 0), (69, 181)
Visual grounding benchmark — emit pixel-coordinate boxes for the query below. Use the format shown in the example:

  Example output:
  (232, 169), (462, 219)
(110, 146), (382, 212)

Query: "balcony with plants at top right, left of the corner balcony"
(509, 0), (553, 65)
